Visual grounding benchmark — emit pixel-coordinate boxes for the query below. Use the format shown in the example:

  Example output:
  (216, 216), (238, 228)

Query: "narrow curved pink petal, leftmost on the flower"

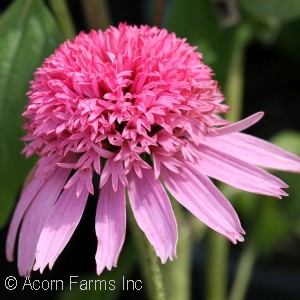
(6, 166), (45, 261)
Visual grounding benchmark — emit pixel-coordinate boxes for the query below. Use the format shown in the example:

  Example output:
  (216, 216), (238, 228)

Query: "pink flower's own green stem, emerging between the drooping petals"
(127, 205), (166, 300)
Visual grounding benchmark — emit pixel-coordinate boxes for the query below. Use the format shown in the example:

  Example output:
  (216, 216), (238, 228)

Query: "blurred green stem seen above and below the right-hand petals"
(206, 24), (251, 300)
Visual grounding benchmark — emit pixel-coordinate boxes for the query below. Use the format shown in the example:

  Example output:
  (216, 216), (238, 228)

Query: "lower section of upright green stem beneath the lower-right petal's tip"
(206, 231), (229, 300)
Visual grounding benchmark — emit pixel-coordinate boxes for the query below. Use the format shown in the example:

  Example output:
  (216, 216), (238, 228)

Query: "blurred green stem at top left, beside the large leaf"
(49, 0), (76, 38)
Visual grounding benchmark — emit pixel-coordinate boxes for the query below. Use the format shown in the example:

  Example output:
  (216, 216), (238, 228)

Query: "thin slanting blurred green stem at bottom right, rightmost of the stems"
(229, 244), (257, 300)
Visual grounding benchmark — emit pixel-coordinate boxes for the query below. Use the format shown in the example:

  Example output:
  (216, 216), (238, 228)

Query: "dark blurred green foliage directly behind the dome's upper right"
(167, 0), (250, 86)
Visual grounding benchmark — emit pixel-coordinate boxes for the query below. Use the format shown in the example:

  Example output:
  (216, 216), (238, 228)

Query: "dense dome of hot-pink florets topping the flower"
(23, 24), (227, 192)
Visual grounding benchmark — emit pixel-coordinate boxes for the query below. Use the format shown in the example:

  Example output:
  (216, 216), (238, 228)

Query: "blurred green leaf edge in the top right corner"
(240, 0), (300, 22)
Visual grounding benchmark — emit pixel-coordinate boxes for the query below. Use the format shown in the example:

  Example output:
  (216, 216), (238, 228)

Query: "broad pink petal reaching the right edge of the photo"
(206, 133), (300, 172)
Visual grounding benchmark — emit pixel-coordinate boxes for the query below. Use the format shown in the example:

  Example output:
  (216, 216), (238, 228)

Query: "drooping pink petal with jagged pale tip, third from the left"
(33, 185), (88, 273)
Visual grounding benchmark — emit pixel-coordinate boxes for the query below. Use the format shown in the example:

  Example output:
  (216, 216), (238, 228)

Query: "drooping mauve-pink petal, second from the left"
(18, 168), (70, 276)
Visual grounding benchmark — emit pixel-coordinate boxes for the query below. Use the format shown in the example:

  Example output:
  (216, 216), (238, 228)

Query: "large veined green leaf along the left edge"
(0, 0), (61, 227)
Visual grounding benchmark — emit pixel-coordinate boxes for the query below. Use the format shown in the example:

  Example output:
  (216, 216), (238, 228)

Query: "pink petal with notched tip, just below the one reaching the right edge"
(197, 145), (287, 198)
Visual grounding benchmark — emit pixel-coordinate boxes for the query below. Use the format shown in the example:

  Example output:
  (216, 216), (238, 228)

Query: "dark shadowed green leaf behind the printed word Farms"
(58, 242), (137, 300)
